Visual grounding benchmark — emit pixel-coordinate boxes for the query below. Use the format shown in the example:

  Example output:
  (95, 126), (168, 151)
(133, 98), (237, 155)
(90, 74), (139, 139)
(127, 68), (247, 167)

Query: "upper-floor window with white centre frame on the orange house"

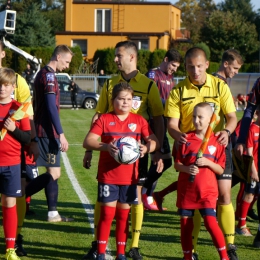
(96, 9), (111, 32)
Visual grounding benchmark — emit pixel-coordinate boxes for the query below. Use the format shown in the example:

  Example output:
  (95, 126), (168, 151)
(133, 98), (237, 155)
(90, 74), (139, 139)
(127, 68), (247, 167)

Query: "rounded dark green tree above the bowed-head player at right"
(202, 11), (259, 62)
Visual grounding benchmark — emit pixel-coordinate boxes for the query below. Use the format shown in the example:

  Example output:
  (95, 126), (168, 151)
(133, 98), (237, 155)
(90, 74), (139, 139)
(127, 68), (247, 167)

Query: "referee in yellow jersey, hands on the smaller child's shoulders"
(164, 47), (237, 260)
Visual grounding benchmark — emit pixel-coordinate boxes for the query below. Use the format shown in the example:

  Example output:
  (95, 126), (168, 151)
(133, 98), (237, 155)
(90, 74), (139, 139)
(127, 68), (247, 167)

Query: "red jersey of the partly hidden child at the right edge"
(246, 123), (259, 171)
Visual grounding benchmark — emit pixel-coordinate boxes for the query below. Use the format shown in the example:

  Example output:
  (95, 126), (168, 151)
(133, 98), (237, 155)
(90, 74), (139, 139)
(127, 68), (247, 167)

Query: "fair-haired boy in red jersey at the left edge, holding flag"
(0, 68), (31, 260)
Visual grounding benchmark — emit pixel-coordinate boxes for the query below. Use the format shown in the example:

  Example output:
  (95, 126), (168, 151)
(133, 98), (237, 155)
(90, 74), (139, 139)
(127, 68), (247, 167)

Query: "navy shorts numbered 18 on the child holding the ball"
(98, 182), (138, 204)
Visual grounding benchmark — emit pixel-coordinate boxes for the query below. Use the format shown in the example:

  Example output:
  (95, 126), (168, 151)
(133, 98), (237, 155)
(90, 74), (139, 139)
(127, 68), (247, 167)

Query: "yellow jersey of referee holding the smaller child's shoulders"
(164, 74), (236, 133)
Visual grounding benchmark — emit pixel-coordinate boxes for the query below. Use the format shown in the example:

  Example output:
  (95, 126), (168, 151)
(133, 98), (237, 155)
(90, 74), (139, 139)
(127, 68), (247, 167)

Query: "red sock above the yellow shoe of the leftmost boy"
(2, 205), (17, 249)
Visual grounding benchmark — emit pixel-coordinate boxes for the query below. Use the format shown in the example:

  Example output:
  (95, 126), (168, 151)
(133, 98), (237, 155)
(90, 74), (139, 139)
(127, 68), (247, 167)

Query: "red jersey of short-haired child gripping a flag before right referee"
(175, 132), (226, 209)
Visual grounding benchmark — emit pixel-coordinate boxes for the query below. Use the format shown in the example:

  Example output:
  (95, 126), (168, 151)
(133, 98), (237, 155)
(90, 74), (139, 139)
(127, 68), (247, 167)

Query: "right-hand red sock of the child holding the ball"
(116, 208), (130, 256)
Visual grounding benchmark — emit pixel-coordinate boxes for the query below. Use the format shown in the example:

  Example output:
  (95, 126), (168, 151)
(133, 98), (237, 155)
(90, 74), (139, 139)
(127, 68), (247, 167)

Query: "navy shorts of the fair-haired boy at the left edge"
(0, 164), (22, 197)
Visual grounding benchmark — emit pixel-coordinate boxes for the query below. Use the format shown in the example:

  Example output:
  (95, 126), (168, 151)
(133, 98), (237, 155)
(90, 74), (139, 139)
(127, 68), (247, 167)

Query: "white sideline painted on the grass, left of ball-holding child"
(61, 153), (113, 260)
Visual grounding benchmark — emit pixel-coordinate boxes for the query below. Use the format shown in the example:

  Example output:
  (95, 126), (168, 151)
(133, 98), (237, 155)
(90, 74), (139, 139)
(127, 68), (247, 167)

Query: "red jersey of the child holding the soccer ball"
(90, 112), (152, 185)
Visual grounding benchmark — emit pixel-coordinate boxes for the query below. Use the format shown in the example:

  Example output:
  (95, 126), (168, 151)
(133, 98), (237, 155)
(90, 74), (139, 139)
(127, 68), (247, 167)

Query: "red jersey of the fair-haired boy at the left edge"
(0, 100), (31, 166)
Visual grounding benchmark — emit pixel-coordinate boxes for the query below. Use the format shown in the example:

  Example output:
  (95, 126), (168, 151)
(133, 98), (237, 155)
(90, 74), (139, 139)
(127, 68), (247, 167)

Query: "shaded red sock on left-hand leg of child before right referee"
(181, 218), (193, 259)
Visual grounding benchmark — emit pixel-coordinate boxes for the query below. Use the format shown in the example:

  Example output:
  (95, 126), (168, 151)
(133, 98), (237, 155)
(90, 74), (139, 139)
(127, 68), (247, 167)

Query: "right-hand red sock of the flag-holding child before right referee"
(204, 216), (229, 260)
